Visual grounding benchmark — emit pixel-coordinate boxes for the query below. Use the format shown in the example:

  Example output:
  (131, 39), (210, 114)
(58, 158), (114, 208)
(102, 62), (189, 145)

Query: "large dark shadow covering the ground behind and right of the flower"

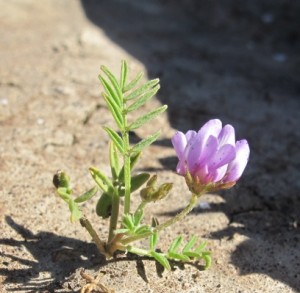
(81, 0), (300, 289)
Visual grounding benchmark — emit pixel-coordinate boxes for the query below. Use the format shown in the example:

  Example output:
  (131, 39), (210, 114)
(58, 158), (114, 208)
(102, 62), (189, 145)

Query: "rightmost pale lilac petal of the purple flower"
(223, 139), (250, 182)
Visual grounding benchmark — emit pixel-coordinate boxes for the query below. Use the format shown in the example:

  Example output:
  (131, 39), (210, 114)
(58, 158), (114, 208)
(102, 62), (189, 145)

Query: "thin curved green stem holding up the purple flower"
(122, 194), (199, 245)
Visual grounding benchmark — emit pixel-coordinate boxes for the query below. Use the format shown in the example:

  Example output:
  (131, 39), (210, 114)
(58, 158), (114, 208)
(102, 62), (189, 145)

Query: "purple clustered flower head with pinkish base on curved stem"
(172, 119), (250, 193)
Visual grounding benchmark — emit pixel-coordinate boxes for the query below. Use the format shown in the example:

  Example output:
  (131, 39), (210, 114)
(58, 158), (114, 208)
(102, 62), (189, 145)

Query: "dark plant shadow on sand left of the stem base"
(0, 216), (204, 292)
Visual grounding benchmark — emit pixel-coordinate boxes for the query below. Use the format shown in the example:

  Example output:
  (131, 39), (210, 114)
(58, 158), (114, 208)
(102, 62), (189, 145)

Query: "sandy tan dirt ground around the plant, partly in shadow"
(0, 0), (300, 293)
